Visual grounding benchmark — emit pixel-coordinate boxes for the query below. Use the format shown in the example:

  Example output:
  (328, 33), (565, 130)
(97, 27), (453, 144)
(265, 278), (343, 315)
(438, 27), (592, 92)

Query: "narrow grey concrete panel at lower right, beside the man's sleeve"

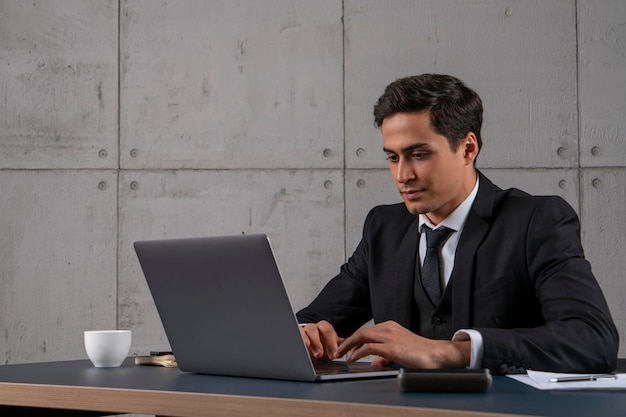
(581, 168), (626, 357)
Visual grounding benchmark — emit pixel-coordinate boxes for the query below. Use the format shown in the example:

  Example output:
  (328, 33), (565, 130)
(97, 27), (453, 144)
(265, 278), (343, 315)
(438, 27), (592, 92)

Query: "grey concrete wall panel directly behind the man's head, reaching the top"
(345, 0), (578, 168)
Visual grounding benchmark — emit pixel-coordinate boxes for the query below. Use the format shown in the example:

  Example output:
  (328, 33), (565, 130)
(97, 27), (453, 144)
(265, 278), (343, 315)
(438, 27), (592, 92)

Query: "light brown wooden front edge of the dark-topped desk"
(0, 382), (528, 417)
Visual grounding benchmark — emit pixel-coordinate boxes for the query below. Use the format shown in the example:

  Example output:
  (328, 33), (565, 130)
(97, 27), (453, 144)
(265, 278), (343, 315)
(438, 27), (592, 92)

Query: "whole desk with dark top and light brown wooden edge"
(0, 359), (626, 417)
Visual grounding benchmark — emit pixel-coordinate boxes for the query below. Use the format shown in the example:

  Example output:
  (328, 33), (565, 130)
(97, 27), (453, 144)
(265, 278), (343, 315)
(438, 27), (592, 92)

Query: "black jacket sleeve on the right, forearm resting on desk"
(476, 197), (619, 373)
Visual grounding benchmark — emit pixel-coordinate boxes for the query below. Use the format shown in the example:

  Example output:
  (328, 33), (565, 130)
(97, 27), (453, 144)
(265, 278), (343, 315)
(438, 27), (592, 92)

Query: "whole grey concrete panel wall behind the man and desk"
(0, 0), (626, 363)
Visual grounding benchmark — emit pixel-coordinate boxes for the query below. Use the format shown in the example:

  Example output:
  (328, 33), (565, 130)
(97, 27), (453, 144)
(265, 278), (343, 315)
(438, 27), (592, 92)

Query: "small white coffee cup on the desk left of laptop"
(85, 330), (131, 368)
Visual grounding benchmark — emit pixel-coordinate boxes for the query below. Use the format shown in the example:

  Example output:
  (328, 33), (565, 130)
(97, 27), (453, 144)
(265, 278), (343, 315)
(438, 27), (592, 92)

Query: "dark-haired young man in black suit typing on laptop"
(297, 74), (618, 374)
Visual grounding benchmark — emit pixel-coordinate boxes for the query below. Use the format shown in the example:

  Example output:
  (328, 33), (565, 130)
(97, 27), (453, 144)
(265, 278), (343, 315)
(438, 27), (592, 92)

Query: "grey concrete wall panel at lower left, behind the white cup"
(0, 170), (117, 363)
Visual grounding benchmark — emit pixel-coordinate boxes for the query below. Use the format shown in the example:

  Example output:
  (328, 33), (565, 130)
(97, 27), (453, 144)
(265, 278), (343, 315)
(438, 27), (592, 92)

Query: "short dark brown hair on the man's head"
(374, 74), (483, 151)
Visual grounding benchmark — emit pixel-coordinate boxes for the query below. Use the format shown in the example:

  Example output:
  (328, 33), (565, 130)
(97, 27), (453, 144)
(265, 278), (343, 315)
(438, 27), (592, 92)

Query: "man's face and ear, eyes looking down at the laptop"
(381, 111), (478, 224)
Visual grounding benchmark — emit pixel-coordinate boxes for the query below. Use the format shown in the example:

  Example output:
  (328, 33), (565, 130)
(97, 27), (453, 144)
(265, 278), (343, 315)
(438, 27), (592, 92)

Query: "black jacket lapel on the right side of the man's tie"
(450, 172), (498, 329)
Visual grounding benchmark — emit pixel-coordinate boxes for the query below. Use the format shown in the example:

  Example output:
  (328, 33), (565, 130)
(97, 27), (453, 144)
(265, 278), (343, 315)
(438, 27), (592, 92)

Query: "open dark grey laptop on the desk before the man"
(134, 234), (398, 381)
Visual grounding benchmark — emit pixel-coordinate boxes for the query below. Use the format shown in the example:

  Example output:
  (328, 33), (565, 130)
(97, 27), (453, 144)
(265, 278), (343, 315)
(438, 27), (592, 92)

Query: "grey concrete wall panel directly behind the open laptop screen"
(119, 170), (345, 352)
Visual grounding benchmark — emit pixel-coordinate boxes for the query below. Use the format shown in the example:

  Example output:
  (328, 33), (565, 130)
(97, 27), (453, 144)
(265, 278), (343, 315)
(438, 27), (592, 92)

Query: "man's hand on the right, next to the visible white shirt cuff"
(335, 321), (470, 369)
